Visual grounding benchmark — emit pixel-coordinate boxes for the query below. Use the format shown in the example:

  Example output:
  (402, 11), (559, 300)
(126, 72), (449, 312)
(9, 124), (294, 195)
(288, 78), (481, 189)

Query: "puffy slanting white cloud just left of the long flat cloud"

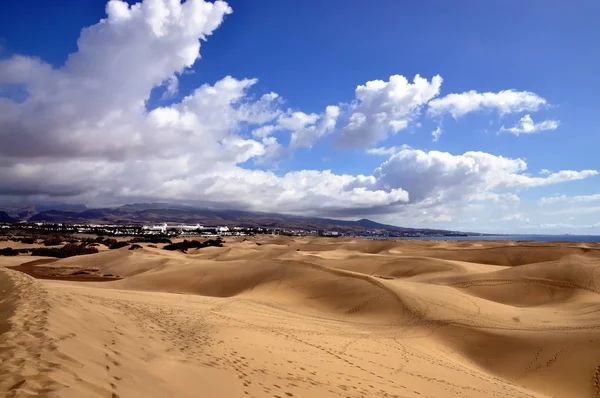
(340, 75), (442, 147)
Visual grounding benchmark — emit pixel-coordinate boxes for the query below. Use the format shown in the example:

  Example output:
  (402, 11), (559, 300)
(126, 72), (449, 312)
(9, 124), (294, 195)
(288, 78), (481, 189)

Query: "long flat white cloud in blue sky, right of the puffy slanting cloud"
(427, 90), (547, 119)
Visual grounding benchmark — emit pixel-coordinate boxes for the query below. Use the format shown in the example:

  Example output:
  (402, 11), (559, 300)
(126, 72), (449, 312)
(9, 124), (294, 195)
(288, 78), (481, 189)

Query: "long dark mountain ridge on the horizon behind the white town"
(22, 203), (468, 235)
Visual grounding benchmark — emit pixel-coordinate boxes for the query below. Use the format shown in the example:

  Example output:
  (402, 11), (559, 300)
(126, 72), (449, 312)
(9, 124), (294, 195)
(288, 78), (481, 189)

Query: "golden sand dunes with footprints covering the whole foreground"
(0, 237), (600, 398)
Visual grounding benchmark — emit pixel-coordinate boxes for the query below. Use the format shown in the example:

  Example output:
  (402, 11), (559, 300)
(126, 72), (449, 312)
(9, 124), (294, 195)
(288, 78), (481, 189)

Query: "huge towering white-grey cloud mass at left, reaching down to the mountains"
(0, 0), (407, 212)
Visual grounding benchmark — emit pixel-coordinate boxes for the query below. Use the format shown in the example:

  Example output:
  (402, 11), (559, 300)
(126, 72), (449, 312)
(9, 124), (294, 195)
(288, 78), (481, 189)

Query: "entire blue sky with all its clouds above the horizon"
(0, 0), (600, 233)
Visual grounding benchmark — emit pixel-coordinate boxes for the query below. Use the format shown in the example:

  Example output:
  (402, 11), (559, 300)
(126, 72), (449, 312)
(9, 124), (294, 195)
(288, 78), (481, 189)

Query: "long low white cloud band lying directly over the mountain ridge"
(0, 157), (408, 214)
